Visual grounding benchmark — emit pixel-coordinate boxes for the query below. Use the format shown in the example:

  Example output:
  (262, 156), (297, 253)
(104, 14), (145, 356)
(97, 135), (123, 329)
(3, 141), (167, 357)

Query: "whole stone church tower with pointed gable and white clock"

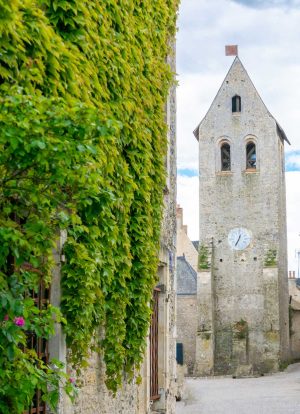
(194, 57), (289, 376)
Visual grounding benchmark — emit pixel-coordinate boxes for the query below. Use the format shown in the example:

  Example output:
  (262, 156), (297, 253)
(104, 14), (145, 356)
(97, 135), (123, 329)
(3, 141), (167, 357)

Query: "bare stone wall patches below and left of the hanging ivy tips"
(49, 236), (151, 414)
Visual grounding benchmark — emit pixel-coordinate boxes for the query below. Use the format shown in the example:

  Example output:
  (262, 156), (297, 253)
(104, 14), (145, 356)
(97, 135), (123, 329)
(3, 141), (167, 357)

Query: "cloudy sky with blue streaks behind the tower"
(177, 0), (300, 274)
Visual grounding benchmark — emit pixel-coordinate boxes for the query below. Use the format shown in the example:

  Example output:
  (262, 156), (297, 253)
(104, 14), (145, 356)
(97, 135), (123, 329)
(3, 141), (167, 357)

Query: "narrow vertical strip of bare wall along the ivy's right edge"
(151, 38), (177, 414)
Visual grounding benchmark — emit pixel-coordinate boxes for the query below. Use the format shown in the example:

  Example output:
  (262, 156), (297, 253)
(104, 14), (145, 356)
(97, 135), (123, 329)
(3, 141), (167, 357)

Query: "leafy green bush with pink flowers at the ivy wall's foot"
(0, 273), (76, 414)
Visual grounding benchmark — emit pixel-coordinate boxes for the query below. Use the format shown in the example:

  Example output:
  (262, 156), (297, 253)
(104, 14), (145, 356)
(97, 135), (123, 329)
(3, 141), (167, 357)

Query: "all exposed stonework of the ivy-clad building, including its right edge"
(49, 45), (178, 414)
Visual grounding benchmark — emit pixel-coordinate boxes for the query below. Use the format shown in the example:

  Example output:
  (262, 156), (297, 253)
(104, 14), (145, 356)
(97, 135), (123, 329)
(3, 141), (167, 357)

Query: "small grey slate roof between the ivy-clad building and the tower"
(176, 256), (197, 295)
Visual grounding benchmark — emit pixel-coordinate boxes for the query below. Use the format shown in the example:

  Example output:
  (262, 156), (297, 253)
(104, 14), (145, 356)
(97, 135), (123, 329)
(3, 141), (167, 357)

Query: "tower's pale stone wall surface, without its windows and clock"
(199, 61), (288, 373)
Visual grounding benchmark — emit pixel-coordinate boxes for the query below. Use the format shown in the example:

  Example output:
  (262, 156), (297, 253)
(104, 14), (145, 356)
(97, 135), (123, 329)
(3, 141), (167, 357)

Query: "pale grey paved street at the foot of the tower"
(176, 363), (300, 414)
